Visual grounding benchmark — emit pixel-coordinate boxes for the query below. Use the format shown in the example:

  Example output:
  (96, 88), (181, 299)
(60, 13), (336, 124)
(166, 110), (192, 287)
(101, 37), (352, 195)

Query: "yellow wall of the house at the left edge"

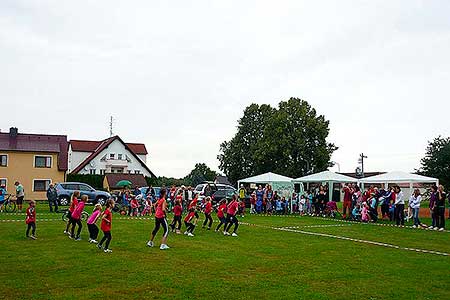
(0, 151), (65, 200)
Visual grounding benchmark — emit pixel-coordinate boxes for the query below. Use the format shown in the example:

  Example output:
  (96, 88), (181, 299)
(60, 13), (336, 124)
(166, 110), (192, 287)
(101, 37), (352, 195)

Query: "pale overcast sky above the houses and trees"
(0, 0), (450, 177)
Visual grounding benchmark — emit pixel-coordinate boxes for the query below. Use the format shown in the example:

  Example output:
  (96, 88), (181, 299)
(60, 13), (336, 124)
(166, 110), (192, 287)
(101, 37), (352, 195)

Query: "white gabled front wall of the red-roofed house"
(72, 140), (151, 177)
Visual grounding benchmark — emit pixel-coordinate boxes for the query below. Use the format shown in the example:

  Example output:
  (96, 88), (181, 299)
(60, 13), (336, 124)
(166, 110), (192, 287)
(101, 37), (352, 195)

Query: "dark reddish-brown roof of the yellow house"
(0, 133), (69, 171)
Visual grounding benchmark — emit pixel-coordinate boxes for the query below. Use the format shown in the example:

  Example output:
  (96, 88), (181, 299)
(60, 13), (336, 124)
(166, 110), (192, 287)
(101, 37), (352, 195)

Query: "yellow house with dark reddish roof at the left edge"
(0, 128), (68, 200)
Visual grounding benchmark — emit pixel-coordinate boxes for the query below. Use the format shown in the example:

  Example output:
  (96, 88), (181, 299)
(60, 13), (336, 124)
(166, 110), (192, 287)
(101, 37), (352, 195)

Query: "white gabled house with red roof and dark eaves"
(68, 136), (155, 177)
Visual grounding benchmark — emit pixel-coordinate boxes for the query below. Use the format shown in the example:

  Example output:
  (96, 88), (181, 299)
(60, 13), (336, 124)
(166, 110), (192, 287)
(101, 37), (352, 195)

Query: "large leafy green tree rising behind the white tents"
(218, 98), (337, 183)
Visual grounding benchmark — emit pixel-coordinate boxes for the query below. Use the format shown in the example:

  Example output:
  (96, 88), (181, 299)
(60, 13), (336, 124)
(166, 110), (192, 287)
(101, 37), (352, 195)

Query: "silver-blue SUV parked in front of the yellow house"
(56, 182), (111, 205)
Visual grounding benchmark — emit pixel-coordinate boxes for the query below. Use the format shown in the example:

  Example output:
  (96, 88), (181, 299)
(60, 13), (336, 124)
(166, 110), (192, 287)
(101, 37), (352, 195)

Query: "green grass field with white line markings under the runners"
(0, 206), (450, 299)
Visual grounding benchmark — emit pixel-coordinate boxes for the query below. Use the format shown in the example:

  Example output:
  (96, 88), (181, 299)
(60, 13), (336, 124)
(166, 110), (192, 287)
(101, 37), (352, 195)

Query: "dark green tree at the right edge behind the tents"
(418, 136), (450, 189)
